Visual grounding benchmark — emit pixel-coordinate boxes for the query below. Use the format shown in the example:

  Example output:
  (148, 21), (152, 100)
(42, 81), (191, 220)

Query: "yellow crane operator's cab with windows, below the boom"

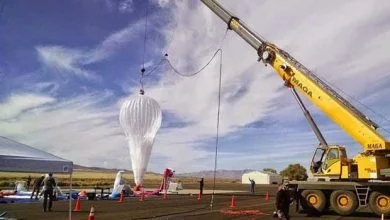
(310, 145), (351, 179)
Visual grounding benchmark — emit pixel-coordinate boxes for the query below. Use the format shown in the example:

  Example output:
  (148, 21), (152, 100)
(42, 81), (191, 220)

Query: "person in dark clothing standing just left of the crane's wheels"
(275, 183), (291, 220)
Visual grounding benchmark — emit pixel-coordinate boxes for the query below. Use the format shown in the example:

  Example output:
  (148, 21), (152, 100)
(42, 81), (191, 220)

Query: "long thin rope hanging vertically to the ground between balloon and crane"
(210, 48), (222, 210)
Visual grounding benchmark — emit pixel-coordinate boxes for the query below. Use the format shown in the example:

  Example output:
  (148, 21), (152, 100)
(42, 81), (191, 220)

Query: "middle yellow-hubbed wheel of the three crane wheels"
(330, 190), (359, 216)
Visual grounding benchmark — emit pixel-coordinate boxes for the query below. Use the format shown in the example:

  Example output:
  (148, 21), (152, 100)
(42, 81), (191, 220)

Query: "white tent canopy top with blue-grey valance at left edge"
(0, 136), (73, 173)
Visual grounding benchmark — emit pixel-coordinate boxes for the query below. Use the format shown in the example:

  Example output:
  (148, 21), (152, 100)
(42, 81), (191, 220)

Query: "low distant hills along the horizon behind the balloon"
(73, 164), (254, 179)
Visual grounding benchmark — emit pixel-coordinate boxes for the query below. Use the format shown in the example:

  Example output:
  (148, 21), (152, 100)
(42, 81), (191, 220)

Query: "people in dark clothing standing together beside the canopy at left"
(27, 173), (57, 212)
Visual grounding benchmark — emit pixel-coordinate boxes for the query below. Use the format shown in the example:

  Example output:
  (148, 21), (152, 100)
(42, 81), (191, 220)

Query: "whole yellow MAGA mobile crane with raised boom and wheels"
(201, 0), (390, 216)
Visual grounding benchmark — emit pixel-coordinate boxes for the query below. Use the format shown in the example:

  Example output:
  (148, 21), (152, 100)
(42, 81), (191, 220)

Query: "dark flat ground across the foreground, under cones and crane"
(0, 188), (379, 220)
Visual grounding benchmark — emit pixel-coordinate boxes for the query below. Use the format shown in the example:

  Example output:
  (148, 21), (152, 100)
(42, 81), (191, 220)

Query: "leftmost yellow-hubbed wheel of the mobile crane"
(300, 190), (326, 215)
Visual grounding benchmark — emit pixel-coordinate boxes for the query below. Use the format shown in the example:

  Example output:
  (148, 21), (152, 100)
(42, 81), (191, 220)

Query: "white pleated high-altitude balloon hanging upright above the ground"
(119, 95), (162, 187)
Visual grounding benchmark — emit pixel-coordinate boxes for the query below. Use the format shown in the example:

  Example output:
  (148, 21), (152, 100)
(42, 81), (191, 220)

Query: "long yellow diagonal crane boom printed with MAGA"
(201, 0), (390, 151)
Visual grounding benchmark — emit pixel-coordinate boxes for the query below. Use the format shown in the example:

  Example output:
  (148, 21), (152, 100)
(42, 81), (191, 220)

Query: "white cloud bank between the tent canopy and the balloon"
(0, 92), (129, 168)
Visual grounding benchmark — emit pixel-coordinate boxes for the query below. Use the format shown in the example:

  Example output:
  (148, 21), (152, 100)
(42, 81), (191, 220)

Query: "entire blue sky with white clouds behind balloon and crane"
(0, 0), (390, 172)
